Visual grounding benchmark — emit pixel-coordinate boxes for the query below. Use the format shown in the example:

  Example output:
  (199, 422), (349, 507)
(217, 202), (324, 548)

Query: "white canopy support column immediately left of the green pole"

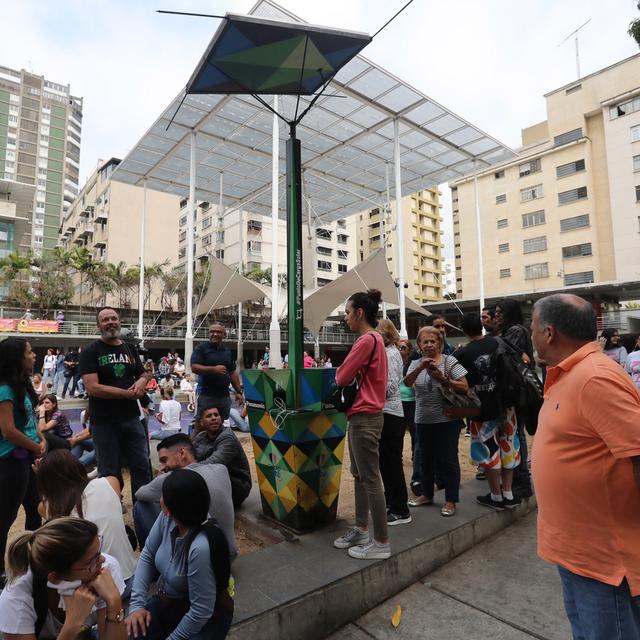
(269, 96), (282, 369)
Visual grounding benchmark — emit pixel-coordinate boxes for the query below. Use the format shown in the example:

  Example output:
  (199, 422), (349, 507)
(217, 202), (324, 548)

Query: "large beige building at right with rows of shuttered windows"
(451, 55), (640, 299)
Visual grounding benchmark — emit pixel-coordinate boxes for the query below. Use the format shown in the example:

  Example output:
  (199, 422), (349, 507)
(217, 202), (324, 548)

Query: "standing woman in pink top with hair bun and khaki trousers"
(333, 289), (391, 560)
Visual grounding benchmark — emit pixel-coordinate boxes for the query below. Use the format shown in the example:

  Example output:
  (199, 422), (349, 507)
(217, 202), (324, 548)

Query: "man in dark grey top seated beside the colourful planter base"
(193, 407), (251, 509)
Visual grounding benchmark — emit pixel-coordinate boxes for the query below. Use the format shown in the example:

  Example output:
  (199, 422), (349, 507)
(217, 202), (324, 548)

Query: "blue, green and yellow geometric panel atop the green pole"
(186, 14), (371, 95)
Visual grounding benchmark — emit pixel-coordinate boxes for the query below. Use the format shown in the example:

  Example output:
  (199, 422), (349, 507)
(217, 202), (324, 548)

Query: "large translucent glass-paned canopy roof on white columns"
(113, 0), (515, 222)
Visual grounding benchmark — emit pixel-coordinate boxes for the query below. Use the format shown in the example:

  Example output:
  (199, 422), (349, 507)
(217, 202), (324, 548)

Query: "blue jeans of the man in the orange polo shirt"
(558, 567), (640, 640)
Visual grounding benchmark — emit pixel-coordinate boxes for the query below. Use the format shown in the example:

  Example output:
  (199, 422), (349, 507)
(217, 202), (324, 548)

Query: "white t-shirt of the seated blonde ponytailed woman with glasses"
(0, 553), (124, 640)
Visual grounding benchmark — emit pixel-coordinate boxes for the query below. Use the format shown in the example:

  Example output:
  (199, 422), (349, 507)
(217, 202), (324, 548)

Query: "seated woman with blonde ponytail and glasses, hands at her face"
(0, 518), (127, 640)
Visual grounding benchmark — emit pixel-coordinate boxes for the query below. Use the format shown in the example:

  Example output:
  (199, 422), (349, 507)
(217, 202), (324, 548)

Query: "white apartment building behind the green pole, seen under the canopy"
(178, 200), (357, 289)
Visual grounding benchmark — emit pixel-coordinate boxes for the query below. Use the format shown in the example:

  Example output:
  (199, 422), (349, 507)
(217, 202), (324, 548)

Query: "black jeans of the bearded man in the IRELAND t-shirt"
(91, 416), (151, 502)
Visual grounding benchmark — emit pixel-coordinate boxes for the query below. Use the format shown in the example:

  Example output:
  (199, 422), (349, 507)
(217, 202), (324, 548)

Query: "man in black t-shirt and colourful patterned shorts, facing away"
(455, 313), (521, 511)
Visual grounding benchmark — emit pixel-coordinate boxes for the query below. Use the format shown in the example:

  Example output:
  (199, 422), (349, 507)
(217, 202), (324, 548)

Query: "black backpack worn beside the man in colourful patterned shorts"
(495, 338), (544, 435)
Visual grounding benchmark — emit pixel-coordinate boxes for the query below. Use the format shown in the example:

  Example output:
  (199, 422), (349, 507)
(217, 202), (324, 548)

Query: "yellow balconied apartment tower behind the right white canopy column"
(357, 187), (444, 304)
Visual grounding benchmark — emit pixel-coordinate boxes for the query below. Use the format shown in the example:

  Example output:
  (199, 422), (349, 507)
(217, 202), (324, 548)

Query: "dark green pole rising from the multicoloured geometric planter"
(287, 124), (304, 408)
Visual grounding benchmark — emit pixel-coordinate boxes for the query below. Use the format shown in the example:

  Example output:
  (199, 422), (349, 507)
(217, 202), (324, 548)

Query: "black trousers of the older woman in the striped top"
(416, 420), (462, 502)
